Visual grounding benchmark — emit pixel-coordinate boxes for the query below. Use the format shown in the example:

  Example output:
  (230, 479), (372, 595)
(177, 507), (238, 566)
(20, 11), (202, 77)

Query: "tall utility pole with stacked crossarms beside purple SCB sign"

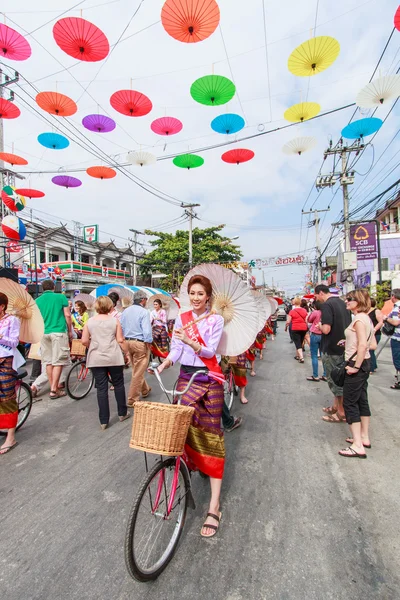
(316, 137), (368, 291)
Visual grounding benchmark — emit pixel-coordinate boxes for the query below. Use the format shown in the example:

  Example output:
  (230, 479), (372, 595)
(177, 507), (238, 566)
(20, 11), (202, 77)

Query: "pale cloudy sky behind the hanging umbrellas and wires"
(1, 0), (400, 293)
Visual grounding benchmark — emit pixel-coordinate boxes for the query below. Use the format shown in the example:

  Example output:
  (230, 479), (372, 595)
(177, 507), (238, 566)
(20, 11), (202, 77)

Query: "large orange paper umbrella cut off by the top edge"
(161, 0), (220, 44)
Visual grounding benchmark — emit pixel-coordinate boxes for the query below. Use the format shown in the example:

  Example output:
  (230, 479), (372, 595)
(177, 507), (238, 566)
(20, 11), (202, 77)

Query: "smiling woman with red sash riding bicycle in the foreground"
(158, 275), (225, 537)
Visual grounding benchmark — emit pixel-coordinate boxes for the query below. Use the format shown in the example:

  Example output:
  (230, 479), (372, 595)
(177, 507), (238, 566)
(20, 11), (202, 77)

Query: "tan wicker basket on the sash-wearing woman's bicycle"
(129, 402), (194, 456)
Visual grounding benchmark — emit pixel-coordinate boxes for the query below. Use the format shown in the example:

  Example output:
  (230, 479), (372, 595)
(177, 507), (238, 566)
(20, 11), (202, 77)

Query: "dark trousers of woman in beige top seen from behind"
(92, 366), (127, 425)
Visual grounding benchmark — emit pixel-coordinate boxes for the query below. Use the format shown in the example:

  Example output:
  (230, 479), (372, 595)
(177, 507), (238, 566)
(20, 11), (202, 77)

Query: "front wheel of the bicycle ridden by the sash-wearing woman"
(125, 457), (190, 581)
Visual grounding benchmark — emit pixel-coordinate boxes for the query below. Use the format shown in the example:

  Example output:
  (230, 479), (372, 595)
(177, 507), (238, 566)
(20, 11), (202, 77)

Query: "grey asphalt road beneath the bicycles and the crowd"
(0, 327), (400, 600)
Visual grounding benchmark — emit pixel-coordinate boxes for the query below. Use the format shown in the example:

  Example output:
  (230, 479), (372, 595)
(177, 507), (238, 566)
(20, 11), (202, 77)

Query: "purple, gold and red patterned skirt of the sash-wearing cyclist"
(176, 371), (225, 479)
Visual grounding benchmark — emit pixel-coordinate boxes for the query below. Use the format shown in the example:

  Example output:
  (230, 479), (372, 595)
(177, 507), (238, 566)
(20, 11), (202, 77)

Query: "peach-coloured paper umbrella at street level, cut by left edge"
(0, 277), (44, 344)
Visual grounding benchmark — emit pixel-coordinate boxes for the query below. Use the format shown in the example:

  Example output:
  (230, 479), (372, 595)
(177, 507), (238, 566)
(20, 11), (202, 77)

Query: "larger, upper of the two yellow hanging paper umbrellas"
(288, 36), (340, 77)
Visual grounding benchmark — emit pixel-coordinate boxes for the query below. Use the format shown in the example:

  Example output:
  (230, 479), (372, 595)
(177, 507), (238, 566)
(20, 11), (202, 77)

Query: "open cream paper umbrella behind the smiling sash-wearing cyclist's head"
(179, 264), (259, 356)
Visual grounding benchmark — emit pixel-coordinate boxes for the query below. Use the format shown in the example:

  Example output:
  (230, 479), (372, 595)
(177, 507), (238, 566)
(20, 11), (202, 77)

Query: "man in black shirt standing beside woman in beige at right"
(315, 284), (351, 423)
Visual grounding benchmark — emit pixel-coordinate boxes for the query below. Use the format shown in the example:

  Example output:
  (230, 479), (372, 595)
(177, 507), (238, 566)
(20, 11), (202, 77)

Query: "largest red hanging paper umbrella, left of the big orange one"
(53, 17), (110, 62)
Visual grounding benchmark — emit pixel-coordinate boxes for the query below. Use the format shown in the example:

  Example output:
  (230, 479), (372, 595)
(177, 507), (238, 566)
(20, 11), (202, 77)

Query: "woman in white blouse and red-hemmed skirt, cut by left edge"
(0, 293), (20, 455)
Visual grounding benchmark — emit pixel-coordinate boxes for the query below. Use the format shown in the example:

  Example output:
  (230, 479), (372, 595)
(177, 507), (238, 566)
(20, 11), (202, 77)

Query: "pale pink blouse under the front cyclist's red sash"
(168, 315), (224, 367)
